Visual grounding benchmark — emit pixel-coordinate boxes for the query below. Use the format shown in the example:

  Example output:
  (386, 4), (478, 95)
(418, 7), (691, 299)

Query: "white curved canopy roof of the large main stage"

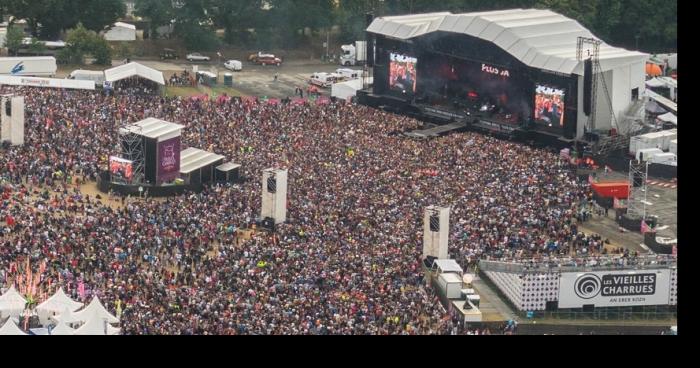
(367, 9), (649, 75)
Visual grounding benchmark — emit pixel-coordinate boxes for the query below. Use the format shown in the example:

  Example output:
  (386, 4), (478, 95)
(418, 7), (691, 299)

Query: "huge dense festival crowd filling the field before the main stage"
(0, 87), (600, 334)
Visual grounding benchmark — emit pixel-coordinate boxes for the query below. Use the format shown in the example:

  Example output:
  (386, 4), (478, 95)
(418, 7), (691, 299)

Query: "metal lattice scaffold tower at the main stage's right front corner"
(576, 37), (619, 140)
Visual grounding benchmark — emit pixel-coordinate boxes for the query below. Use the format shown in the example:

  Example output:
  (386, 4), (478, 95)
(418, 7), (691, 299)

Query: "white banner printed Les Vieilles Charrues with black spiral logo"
(559, 269), (670, 308)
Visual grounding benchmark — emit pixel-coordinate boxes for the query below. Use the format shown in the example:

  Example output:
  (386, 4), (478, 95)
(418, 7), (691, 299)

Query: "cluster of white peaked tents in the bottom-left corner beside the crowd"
(0, 286), (120, 336)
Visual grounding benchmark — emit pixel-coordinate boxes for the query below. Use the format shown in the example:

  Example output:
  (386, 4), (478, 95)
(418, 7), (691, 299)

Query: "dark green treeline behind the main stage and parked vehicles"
(0, 0), (678, 52)
